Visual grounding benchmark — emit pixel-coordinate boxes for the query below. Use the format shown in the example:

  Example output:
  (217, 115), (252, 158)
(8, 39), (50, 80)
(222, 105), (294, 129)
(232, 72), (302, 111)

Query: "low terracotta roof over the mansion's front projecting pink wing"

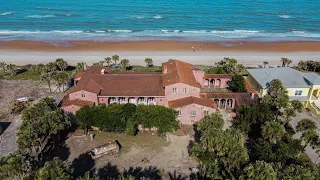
(168, 96), (217, 108)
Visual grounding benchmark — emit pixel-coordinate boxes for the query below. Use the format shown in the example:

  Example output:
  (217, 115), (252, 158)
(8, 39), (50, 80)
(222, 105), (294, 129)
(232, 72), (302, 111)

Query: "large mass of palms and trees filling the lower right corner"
(191, 80), (320, 180)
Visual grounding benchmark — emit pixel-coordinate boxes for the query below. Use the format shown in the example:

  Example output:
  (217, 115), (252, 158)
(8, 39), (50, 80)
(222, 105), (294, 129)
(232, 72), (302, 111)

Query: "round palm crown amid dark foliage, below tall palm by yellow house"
(262, 121), (286, 144)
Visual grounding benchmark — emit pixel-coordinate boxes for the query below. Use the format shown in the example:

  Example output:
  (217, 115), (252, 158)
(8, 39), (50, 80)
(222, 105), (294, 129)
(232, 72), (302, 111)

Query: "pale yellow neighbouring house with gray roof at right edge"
(247, 67), (320, 118)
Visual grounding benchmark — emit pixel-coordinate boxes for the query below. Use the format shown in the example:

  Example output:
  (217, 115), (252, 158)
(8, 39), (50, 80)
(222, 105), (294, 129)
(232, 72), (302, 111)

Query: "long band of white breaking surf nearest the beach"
(0, 29), (320, 39)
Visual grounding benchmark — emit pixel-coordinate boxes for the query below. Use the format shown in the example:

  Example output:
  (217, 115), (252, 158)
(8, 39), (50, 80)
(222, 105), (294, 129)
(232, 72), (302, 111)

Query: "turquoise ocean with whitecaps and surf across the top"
(0, 0), (320, 41)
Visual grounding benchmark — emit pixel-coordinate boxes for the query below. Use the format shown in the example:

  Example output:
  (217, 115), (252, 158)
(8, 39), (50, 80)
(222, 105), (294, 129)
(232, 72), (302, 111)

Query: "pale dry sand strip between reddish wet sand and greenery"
(0, 50), (320, 67)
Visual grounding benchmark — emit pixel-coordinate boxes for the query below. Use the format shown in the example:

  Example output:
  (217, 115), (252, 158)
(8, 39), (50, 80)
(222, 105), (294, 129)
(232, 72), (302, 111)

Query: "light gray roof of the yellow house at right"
(247, 67), (320, 88)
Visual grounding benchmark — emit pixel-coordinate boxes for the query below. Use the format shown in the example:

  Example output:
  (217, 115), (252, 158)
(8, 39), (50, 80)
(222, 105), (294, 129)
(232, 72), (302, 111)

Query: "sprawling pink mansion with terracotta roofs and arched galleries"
(62, 60), (254, 124)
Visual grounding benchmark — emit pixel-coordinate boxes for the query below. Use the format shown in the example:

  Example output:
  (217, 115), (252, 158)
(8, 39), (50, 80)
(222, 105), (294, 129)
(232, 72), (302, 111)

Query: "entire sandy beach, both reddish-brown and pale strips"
(0, 41), (320, 66)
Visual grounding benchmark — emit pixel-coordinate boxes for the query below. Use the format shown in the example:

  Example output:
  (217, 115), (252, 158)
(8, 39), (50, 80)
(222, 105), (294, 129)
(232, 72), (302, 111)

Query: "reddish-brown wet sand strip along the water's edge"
(0, 40), (320, 53)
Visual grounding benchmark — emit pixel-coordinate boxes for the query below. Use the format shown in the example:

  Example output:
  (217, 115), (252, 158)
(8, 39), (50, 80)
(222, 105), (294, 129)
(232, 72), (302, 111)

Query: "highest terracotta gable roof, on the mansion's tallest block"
(162, 60), (200, 87)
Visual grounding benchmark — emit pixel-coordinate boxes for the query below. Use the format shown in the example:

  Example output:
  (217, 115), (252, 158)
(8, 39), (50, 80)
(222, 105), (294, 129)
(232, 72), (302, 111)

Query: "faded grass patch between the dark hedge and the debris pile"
(90, 131), (168, 152)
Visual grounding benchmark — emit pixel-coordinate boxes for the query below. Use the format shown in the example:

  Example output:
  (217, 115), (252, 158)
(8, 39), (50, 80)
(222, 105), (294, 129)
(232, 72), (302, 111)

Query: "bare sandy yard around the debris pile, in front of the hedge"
(67, 132), (197, 176)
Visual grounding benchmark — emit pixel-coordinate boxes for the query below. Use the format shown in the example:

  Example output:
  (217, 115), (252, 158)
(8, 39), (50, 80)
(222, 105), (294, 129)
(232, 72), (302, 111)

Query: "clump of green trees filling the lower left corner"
(0, 98), (71, 179)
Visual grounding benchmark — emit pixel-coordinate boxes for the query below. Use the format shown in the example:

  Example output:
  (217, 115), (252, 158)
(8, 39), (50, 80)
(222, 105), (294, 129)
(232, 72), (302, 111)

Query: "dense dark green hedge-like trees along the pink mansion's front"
(76, 103), (178, 135)
